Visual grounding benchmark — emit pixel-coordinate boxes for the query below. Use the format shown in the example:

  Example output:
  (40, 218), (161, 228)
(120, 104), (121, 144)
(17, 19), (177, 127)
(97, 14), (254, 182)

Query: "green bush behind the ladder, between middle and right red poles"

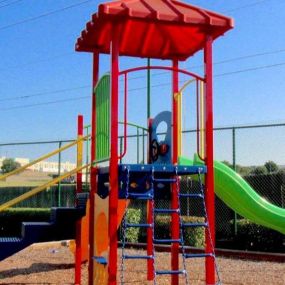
(155, 216), (205, 247)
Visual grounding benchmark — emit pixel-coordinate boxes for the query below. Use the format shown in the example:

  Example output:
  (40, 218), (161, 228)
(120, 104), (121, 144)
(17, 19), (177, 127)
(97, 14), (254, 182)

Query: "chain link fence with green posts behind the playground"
(0, 124), (285, 252)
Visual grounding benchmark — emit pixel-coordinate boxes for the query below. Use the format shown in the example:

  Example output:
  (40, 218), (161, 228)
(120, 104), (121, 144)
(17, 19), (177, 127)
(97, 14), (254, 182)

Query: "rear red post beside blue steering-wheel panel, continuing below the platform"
(146, 118), (154, 280)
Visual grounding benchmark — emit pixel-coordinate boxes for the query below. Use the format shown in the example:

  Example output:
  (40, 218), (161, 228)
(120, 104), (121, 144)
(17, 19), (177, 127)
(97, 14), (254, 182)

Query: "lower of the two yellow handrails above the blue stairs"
(0, 164), (90, 212)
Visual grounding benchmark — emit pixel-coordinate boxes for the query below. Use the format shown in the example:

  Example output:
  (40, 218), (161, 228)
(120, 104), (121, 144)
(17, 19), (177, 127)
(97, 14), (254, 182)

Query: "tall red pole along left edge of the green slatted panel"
(88, 53), (99, 285)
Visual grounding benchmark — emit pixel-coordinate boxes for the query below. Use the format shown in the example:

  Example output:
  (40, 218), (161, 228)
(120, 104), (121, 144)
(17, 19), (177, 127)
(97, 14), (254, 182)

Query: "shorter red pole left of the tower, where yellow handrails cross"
(74, 115), (83, 284)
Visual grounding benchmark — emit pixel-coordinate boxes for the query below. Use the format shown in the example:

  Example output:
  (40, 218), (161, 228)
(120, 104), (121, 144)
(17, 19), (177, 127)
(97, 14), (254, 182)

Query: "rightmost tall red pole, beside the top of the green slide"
(204, 36), (215, 285)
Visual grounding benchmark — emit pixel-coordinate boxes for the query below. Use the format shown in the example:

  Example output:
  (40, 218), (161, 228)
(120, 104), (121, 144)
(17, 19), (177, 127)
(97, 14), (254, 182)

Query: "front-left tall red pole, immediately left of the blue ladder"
(108, 33), (119, 285)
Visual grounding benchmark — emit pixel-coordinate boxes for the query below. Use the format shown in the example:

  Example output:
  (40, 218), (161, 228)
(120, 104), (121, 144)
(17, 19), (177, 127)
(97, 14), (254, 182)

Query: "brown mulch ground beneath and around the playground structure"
(0, 243), (285, 285)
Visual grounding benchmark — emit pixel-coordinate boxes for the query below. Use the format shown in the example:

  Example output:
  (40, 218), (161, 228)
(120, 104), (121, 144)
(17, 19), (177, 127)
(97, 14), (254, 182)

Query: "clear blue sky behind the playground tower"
(0, 0), (285, 164)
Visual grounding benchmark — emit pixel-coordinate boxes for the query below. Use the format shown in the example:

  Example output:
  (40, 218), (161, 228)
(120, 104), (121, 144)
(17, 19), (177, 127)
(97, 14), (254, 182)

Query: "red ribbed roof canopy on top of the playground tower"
(75, 0), (233, 60)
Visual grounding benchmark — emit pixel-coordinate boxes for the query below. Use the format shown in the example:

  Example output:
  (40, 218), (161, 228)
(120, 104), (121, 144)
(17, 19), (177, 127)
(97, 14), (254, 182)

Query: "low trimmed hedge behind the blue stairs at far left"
(0, 208), (50, 236)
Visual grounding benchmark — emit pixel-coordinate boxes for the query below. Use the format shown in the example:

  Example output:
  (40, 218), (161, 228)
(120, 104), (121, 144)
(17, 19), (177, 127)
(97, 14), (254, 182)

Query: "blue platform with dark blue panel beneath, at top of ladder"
(97, 164), (207, 199)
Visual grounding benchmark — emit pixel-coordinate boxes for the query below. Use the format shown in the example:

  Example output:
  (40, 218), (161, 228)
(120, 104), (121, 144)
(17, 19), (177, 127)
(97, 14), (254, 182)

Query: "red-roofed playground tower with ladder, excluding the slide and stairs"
(76, 0), (233, 285)
